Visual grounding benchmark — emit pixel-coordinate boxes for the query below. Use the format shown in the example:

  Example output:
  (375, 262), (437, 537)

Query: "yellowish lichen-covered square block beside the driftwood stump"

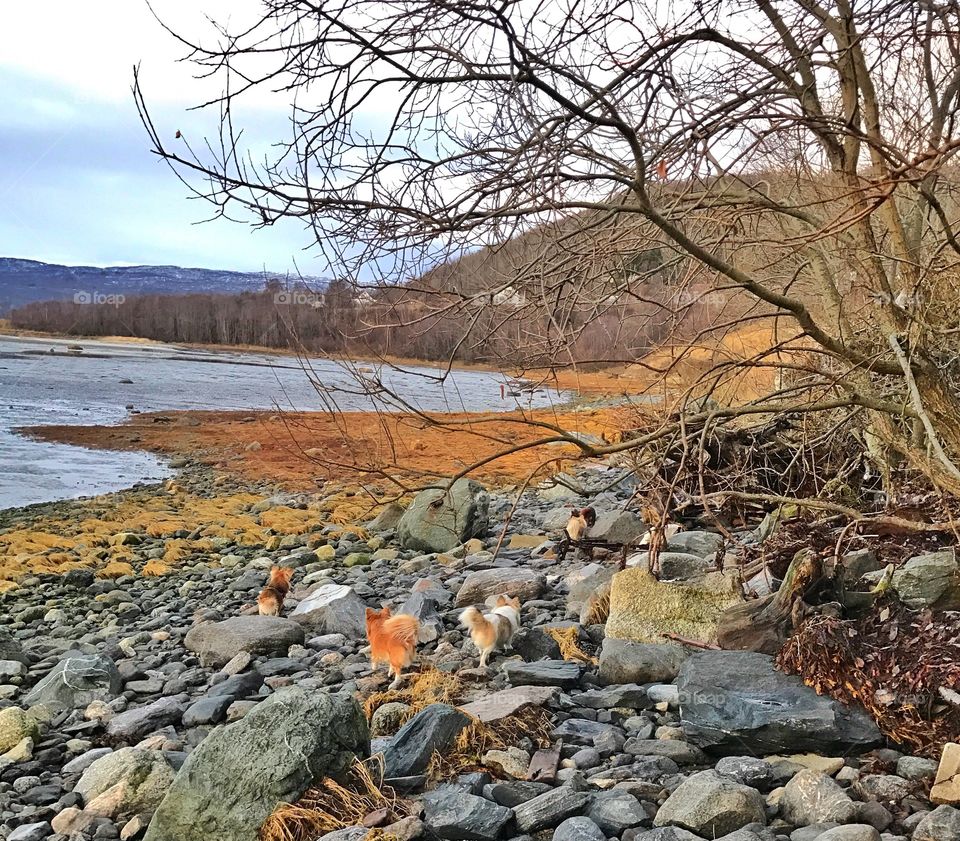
(606, 567), (742, 643)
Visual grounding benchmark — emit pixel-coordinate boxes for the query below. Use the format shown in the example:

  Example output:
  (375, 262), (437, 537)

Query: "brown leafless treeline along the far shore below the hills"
(10, 282), (720, 367)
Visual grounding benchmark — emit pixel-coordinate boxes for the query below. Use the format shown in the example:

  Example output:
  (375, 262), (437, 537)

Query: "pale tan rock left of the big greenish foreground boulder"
(73, 748), (174, 818)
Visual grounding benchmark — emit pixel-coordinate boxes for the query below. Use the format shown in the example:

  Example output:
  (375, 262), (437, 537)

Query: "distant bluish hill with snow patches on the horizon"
(0, 257), (324, 315)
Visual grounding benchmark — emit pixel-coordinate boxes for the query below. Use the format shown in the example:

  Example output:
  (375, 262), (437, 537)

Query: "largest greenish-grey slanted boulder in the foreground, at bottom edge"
(144, 687), (370, 841)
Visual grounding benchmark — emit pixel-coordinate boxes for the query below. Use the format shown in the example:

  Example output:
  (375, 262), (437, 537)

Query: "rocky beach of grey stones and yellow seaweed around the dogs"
(0, 440), (960, 841)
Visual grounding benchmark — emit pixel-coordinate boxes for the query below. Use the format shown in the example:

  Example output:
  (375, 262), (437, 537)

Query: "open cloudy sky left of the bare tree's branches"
(0, 0), (322, 274)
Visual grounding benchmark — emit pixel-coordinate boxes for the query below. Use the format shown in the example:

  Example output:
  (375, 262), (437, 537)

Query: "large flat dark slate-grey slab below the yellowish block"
(677, 651), (882, 755)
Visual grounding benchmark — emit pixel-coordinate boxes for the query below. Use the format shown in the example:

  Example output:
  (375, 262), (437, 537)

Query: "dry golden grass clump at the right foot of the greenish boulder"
(259, 761), (411, 841)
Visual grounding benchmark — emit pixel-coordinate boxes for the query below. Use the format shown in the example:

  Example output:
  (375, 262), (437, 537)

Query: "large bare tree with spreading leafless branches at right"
(135, 0), (960, 506)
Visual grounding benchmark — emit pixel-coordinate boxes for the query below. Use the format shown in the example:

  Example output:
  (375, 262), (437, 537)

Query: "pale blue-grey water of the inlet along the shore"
(0, 336), (558, 509)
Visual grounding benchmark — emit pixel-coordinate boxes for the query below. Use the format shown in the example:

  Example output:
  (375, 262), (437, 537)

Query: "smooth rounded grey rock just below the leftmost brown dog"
(183, 616), (304, 668)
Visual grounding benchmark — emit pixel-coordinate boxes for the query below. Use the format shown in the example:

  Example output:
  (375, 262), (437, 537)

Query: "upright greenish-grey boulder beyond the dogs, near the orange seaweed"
(397, 479), (490, 552)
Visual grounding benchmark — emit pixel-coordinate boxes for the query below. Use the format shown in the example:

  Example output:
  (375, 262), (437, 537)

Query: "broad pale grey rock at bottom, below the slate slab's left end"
(653, 770), (767, 838)
